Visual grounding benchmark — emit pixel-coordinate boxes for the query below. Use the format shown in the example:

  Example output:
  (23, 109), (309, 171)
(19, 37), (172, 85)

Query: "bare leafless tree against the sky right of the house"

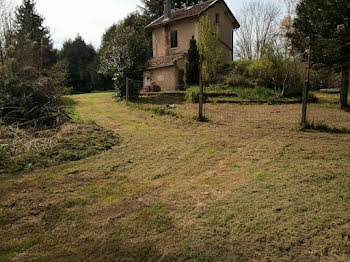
(234, 1), (281, 59)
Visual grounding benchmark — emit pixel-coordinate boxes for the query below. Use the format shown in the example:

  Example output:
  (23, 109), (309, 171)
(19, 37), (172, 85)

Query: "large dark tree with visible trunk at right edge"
(289, 0), (350, 108)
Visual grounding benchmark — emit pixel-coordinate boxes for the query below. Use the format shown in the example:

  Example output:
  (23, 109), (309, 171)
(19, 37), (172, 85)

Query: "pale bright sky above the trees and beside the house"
(14, 0), (278, 48)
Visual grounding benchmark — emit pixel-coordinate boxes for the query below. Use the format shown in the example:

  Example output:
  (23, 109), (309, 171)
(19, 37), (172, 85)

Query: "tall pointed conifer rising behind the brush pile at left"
(14, 0), (57, 73)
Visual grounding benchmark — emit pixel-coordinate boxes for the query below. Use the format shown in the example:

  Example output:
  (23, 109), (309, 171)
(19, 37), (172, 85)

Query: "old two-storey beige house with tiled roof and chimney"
(144, 0), (240, 91)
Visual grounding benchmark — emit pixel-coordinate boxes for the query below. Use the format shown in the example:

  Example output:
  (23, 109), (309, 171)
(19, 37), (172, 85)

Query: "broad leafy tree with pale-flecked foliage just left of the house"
(99, 12), (152, 97)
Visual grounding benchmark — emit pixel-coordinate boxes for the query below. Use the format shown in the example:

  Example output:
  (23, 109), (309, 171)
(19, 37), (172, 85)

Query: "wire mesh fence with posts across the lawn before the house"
(124, 75), (344, 133)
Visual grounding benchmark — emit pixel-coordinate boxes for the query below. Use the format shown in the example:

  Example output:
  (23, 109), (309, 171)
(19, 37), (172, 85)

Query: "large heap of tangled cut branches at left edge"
(0, 77), (67, 128)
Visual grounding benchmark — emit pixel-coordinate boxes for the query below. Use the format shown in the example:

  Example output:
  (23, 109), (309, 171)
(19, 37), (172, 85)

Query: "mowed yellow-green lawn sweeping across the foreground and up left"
(0, 93), (350, 262)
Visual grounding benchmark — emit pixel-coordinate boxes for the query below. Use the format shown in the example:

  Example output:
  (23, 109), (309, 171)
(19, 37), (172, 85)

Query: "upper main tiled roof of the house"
(146, 0), (239, 28)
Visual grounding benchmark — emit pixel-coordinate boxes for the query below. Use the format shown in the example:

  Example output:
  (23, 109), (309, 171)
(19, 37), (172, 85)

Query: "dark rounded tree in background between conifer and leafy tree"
(62, 35), (96, 93)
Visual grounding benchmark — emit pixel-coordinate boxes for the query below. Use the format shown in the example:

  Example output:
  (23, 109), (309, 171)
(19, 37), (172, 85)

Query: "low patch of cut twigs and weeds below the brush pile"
(0, 123), (119, 174)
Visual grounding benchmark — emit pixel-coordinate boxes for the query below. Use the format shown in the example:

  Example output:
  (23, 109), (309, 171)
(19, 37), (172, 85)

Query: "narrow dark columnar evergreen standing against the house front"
(185, 36), (200, 86)
